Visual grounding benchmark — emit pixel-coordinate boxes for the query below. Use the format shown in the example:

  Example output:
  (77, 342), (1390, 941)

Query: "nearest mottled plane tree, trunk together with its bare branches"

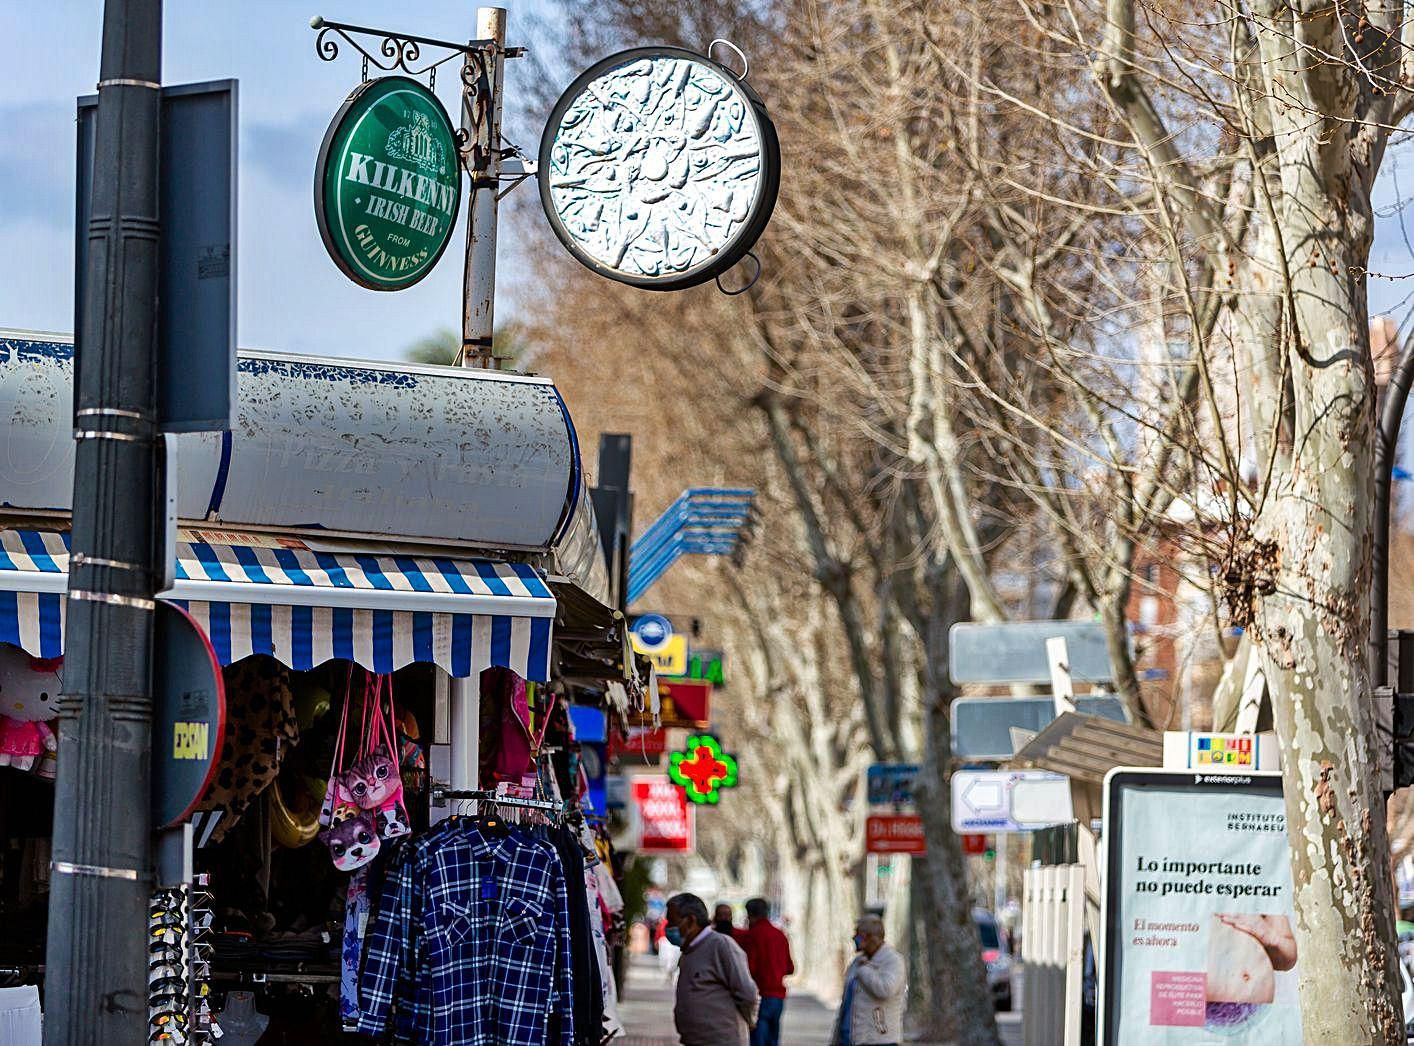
(981, 0), (1410, 1043)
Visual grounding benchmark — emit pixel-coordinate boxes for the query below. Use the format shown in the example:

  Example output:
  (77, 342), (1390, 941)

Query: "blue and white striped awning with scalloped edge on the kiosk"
(0, 530), (556, 681)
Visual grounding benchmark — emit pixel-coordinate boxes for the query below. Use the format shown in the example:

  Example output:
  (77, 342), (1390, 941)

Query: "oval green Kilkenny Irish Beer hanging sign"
(314, 76), (461, 291)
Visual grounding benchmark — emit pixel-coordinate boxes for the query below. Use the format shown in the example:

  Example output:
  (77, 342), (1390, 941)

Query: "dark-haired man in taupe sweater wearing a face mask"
(665, 893), (759, 1046)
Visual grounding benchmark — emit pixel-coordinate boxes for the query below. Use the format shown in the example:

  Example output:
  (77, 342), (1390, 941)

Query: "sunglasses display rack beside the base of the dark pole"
(147, 876), (221, 1046)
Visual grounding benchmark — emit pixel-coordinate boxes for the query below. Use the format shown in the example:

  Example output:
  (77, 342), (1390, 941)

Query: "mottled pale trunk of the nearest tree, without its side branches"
(1240, 3), (1404, 1043)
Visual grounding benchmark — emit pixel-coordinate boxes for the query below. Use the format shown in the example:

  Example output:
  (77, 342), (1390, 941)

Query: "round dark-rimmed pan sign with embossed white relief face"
(539, 47), (781, 291)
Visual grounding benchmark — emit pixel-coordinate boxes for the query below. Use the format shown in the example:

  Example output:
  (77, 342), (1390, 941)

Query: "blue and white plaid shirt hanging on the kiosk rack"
(358, 821), (574, 1046)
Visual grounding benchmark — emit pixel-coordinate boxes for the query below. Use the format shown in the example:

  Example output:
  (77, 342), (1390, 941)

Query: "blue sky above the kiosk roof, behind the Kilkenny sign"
(0, 0), (568, 359)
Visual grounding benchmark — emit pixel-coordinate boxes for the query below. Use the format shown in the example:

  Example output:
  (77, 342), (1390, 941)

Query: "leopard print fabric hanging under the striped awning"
(201, 654), (300, 842)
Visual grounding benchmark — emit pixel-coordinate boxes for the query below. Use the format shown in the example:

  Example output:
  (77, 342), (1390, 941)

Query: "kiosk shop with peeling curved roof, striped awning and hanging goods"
(0, 334), (636, 1042)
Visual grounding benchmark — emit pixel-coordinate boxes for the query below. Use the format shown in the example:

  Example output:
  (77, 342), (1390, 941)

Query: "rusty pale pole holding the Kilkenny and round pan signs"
(461, 7), (506, 368)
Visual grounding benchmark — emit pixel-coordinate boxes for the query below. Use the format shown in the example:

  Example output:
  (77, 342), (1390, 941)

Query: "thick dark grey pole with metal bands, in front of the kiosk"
(44, 0), (163, 1046)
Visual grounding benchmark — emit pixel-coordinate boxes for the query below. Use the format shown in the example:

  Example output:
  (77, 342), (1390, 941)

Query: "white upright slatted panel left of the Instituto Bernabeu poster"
(1021, 865), (1085, 1046)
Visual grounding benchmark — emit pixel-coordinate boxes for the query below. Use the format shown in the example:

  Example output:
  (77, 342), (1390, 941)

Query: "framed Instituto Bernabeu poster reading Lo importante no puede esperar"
(1102, 769), (1301, 1046)
